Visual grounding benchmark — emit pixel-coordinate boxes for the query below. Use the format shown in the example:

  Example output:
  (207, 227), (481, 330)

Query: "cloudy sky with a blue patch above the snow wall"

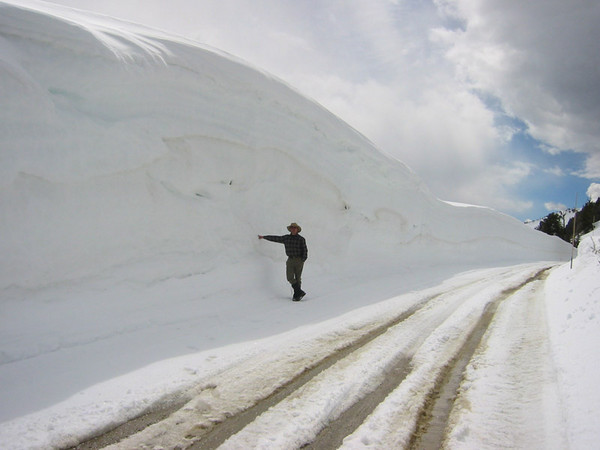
(36, 0), (600, 220)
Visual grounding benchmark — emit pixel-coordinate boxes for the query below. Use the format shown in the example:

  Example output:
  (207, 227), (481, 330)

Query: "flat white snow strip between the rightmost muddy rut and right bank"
(444, 273), (569, 449)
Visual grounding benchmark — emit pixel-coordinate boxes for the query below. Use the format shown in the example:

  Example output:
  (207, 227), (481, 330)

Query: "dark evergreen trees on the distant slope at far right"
(536, 197), (600, 246)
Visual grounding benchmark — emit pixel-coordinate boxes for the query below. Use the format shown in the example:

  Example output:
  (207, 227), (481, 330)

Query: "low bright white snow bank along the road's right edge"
(546, 224), (600, 449)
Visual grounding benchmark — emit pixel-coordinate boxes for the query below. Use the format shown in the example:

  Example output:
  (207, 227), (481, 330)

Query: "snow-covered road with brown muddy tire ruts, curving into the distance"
(75, 264), (564, 449)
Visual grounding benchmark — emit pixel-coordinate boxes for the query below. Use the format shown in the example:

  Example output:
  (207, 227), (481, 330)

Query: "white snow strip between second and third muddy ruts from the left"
(213, 269), (552, 449)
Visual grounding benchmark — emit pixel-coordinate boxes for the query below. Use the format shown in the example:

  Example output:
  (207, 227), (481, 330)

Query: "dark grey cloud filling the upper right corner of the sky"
(436, 0), (600, 176)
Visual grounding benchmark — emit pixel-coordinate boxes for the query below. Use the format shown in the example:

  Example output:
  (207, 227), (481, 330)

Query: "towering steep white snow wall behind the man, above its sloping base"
(0, 2), (570, 288)
